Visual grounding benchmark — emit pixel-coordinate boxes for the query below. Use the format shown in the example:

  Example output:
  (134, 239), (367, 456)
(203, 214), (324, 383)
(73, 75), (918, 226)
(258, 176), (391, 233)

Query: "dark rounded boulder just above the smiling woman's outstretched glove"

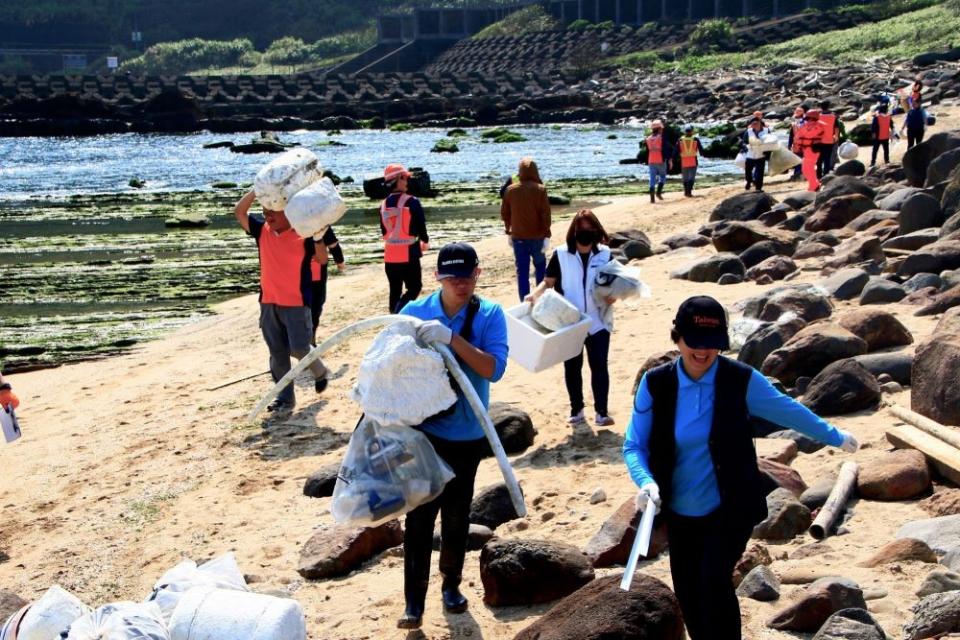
(803, 358), (880, 416)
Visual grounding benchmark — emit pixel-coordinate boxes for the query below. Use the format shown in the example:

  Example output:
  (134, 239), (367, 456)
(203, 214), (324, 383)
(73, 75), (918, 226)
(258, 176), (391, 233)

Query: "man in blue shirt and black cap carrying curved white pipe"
(397, 242), (507, 629)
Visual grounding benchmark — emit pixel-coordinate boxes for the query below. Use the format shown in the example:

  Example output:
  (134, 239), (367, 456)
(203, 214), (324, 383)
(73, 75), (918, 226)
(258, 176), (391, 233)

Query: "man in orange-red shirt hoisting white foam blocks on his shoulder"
(234, 191), (328, 415)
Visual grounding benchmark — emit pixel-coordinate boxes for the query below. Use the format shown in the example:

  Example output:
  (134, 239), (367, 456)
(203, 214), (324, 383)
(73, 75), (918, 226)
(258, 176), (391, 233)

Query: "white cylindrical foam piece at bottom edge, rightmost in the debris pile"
(170, 587), (307, 640)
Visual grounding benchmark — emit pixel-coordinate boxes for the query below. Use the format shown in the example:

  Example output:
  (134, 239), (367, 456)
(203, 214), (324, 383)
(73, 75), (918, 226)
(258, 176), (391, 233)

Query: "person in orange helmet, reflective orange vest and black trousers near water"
(380, 163), (430, 313)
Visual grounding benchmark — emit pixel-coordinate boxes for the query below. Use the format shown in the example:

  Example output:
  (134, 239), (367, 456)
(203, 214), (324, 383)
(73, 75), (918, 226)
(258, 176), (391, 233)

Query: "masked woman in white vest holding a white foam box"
(526, 209), (613, 427)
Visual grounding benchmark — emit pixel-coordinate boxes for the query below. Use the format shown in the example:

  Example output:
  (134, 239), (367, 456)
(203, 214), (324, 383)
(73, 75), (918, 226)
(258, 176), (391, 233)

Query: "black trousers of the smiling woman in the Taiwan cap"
(667, 509), (753, 640)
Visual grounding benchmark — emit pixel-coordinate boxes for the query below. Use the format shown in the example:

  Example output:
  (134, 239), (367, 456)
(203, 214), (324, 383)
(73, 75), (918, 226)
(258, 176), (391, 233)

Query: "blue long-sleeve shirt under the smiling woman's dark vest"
(623, 358), (843, 516)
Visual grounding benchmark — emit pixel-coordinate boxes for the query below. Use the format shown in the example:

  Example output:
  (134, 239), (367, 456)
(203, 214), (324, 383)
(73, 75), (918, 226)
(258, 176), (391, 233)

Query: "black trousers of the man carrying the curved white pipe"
(403, 433), (483, 605)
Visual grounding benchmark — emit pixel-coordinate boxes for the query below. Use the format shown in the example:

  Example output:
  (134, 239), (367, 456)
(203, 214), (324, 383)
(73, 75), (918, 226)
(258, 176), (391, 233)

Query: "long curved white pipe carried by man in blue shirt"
(247, 315), (527, 518)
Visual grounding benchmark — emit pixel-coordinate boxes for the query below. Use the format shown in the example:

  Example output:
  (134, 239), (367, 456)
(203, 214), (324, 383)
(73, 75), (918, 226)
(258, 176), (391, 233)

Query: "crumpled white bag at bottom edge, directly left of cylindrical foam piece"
(65, 602), (170, 640)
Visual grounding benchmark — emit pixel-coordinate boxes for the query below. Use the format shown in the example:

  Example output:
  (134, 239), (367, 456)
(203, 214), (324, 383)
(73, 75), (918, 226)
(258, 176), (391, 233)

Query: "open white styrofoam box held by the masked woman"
(506, 303), (592, 373)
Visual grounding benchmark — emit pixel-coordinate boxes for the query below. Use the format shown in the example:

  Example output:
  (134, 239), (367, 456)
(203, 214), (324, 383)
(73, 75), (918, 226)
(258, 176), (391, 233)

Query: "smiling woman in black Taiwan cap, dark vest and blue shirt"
(623, 296), (858, 640)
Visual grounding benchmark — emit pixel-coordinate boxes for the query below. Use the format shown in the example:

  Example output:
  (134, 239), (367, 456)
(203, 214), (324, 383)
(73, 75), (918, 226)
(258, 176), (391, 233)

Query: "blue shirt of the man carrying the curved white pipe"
(400, 289), (508, 440)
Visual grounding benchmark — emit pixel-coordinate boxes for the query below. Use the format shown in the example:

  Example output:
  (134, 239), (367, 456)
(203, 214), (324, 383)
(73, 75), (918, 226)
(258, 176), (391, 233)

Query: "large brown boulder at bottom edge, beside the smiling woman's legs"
(514, 573), (684, 640)
